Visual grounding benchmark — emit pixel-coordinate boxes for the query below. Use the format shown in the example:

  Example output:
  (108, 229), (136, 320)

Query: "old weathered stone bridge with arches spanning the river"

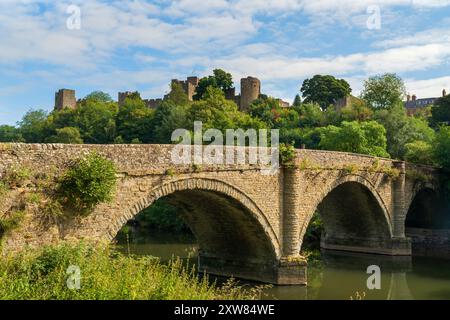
(0, 144), (445, 284)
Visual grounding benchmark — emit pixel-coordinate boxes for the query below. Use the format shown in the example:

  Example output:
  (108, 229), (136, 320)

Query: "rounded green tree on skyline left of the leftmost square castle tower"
(18, 110), (52, 143)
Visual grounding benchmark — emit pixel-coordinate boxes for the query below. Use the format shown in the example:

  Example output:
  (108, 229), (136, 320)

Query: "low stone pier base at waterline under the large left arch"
(198, 254), (307, 285)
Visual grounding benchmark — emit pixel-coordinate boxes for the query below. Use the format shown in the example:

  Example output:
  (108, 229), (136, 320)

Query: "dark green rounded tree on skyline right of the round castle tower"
(300, 75), (352, 110)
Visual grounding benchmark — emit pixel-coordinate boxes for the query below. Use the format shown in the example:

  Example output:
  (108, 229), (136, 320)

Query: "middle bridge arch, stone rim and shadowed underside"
(301, 175), (393, 255)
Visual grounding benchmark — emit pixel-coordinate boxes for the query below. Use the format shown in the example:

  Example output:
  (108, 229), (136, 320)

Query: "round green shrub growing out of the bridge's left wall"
(58, 152), (116, 211)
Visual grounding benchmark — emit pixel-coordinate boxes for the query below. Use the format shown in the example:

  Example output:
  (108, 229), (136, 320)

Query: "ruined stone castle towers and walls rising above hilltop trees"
(55, 77), (289, 111)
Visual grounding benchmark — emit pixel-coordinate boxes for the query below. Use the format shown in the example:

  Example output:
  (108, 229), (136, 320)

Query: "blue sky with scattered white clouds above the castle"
(0, 0), (450, 125)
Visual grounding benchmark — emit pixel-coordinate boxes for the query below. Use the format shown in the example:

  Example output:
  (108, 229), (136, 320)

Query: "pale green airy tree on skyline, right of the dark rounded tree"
(361, 73), (406, 109)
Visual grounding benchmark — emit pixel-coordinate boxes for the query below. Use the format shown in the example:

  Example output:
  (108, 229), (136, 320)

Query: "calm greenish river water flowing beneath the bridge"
(114, 232), (450, 300)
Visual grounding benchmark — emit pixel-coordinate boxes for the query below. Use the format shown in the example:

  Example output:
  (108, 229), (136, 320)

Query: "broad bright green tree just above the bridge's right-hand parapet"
(319, 121), (389, 157)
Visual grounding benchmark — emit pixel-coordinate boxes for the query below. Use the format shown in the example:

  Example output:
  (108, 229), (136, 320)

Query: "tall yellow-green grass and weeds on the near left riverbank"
(0, 245), (261, 300)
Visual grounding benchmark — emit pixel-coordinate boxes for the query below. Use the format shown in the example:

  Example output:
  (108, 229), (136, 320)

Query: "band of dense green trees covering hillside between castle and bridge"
(0, 69), (450, 170)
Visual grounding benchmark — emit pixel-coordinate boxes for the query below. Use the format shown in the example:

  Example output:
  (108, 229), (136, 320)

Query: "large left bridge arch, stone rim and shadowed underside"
(108, 178), (281, 282)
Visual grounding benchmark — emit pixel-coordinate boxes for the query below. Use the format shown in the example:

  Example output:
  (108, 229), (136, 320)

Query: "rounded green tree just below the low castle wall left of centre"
(116, 98), (155, 143)
